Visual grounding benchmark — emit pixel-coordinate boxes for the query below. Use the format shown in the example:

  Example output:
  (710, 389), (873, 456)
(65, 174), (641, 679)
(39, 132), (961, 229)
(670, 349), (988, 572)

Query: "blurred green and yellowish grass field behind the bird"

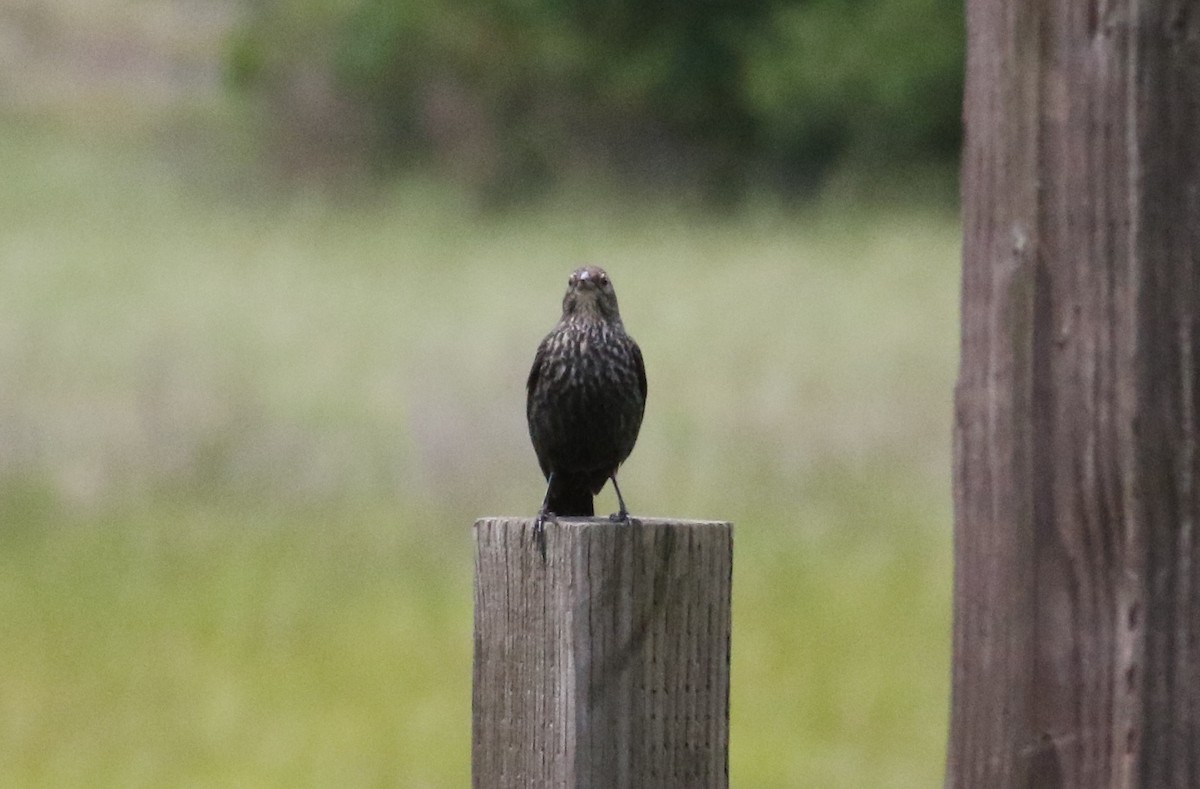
(0, 124), (959, 788)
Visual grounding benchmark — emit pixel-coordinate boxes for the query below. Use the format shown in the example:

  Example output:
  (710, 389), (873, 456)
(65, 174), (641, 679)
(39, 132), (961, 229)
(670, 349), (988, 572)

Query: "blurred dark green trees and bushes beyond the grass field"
(227, 0), (964, 200)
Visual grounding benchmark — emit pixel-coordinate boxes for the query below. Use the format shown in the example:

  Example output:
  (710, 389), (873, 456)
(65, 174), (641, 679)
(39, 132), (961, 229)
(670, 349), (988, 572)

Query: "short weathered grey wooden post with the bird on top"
(472, 518), (733, 789)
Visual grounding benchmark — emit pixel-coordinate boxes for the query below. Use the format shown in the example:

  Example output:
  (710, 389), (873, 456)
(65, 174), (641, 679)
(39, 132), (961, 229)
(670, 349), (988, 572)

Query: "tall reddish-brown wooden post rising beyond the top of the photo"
(946, 0), (1200, 789)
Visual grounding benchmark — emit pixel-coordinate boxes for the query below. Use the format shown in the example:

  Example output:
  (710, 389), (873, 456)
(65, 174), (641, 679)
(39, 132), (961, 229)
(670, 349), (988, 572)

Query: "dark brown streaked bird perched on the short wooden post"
(526, 266), (647, 559)
